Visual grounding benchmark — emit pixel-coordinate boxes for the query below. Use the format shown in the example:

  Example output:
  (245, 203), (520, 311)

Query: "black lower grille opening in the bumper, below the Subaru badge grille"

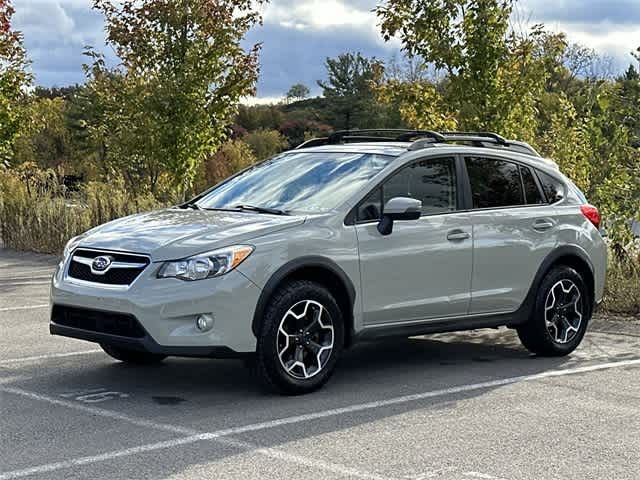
(51, 305), (146, 338)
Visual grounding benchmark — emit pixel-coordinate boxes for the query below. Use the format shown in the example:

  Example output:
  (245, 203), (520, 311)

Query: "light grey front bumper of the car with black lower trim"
(50, 264), (261, 357)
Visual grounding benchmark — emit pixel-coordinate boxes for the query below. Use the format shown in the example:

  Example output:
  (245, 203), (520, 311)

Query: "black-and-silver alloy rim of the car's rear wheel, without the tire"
(544, 279), (583, 344)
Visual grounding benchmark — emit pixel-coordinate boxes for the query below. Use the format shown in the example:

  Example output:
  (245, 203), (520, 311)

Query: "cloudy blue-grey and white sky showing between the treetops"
(14, 0), (640, 98)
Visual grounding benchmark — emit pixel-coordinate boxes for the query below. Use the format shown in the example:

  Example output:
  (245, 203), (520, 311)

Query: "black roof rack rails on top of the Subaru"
(296, 128), (540, 157)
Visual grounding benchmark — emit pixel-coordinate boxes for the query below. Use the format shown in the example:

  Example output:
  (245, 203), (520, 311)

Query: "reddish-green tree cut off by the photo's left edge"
(0, 0), (31, 165)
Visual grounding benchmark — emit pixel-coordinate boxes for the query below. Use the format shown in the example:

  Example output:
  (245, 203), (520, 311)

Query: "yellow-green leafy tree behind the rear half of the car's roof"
(377, 0), (564, 142)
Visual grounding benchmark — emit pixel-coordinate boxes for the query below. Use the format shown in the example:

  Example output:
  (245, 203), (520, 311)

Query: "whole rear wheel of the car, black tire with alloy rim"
(517, 265), (593, 357)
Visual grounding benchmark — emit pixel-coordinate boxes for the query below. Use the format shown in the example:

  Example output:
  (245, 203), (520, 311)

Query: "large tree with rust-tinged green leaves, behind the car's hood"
(86, 0), (263, 193)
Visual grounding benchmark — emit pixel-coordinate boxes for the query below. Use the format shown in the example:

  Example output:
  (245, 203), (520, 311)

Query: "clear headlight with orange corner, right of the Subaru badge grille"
(158, 245), (253, 281)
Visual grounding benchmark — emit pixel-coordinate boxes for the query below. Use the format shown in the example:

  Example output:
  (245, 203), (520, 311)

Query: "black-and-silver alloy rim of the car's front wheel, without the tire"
(276, 300), (334, 380)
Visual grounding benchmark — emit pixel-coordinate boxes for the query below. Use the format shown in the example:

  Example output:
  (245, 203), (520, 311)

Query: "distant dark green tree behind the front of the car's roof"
(318, 53), (380, 130)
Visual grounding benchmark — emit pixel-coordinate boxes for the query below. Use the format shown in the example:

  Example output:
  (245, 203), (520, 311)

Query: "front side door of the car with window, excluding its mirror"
(356, 157), (472, 325)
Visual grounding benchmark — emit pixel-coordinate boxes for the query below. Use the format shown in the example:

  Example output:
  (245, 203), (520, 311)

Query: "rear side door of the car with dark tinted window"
(464, 157), (557, 314)
